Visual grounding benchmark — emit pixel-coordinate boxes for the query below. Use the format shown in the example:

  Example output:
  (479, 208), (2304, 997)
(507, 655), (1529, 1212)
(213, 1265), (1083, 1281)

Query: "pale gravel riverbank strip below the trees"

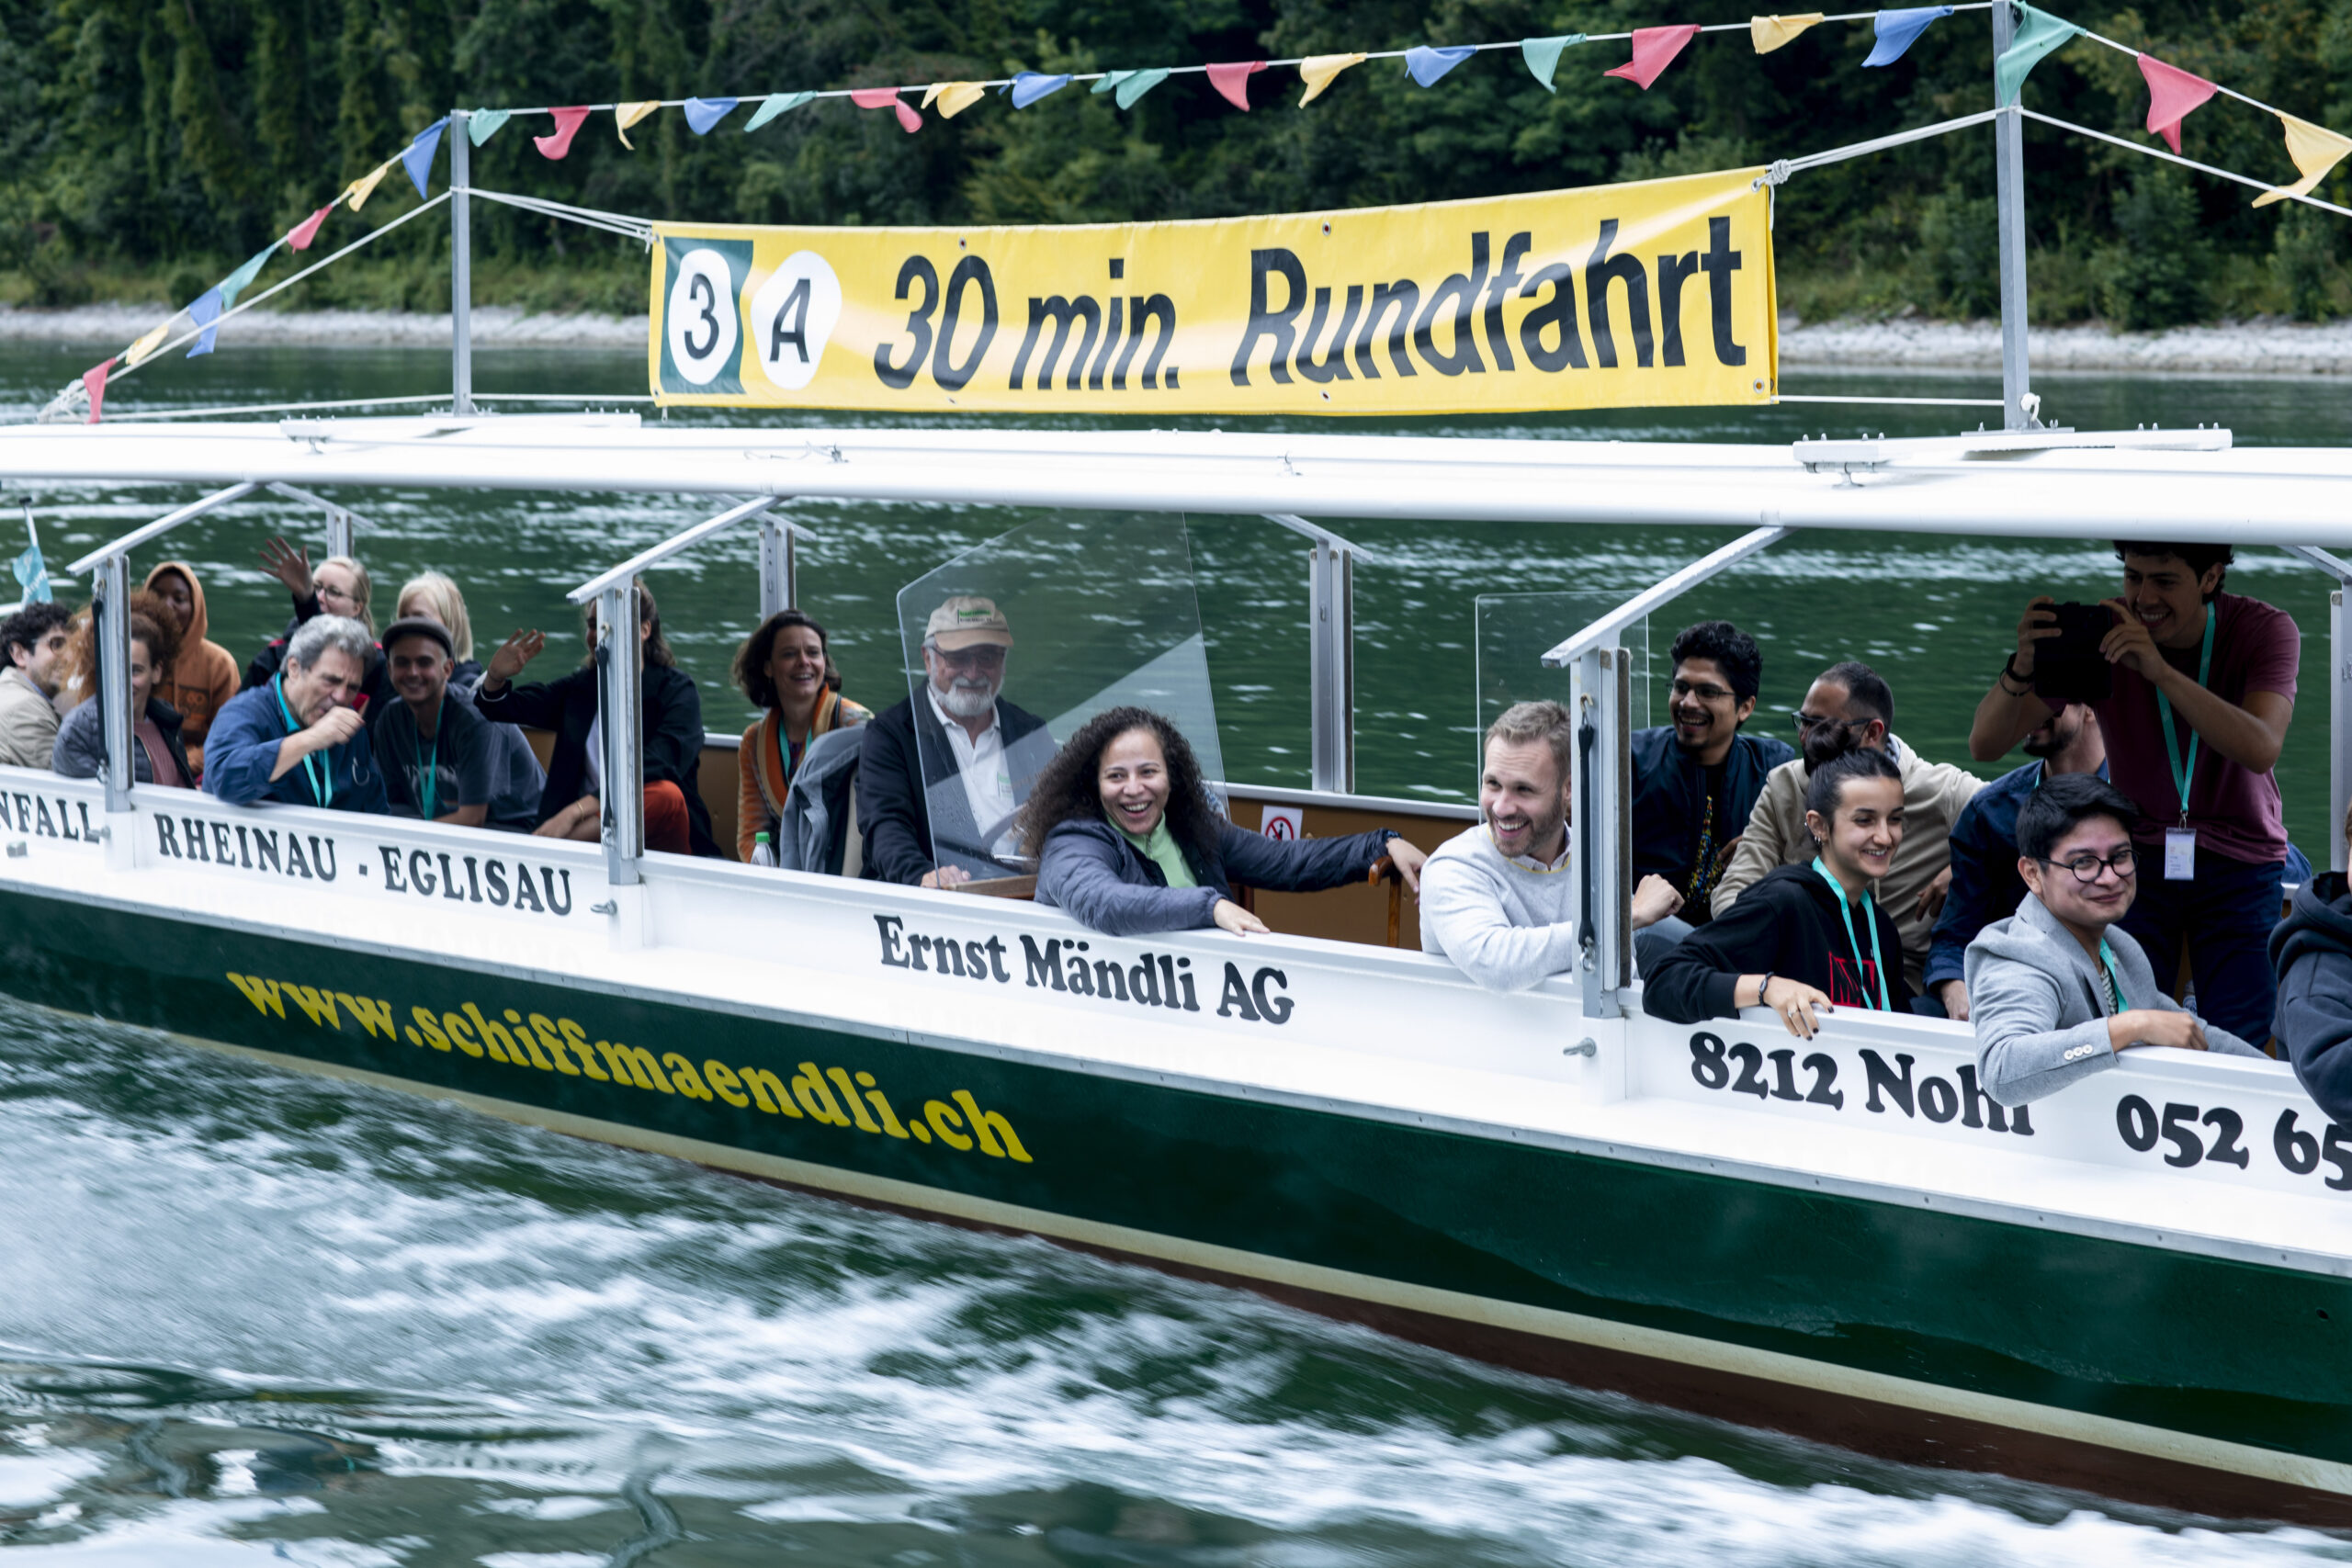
(14, 306), (2352, 376)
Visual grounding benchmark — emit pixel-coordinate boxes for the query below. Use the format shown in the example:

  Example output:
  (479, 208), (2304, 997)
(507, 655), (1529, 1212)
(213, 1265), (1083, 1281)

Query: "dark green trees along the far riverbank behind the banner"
(0, 0), (2352, 327)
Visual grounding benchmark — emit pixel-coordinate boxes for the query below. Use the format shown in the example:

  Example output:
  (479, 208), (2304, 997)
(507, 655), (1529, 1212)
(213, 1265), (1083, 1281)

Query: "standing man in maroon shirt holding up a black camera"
(1969, 541), (2302, 1039)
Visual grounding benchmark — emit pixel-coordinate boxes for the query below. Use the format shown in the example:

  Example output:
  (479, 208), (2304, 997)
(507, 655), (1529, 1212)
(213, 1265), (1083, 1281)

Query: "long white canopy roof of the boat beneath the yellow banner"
(0, 416), (2352, 546)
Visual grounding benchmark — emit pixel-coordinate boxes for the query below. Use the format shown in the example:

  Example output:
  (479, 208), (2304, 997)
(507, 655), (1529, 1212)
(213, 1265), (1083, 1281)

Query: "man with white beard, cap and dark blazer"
(858, 597), (1054, 886)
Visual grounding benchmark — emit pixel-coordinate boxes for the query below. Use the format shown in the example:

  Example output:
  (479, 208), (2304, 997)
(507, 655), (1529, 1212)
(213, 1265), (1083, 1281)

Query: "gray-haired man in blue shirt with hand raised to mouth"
(205, 616), (386, 813)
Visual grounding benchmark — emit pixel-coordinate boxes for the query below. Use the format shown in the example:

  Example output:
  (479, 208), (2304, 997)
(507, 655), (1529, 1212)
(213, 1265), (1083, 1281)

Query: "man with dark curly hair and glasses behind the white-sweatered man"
(1633, 621), (1797, 974)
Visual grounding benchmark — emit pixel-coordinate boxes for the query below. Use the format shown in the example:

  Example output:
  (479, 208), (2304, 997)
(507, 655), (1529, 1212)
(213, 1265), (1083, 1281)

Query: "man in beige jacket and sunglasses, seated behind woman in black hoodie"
(1714, 660), (1983, 995)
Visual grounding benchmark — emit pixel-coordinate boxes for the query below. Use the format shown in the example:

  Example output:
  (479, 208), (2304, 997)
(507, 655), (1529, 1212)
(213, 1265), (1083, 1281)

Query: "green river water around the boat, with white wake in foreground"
(0, 345), (2352, 1568)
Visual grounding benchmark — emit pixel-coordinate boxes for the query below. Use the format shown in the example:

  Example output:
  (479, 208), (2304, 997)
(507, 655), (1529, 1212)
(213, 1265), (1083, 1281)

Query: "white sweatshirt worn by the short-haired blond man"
(1420, 823), (1576, 992)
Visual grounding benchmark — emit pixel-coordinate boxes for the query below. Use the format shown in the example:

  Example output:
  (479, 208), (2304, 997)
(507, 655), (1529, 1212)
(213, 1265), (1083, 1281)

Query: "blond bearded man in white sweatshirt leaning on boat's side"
(1420, 703), (1681, 992)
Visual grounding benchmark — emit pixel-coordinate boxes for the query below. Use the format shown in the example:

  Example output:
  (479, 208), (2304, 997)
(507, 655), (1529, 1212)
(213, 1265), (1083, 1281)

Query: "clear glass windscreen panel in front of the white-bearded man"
(899, 513), (1226, 879)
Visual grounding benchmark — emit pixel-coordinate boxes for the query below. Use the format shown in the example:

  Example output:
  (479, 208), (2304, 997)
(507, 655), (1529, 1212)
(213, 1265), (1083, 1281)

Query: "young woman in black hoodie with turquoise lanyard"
(1642, 750), (1912, 1039)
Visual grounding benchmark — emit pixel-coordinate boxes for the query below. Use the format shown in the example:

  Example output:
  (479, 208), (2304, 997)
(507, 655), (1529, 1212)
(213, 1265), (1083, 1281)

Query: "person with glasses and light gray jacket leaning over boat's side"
(1969, 773), (2263, 1105)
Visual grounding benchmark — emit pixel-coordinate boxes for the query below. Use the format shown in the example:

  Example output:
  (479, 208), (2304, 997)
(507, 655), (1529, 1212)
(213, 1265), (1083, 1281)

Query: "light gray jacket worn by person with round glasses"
(1966, 894), (2265, 1105)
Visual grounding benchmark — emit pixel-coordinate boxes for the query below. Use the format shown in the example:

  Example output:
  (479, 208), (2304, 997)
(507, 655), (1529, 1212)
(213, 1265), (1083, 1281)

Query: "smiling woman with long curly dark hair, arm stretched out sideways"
(1023, 707), (1425, 936)
